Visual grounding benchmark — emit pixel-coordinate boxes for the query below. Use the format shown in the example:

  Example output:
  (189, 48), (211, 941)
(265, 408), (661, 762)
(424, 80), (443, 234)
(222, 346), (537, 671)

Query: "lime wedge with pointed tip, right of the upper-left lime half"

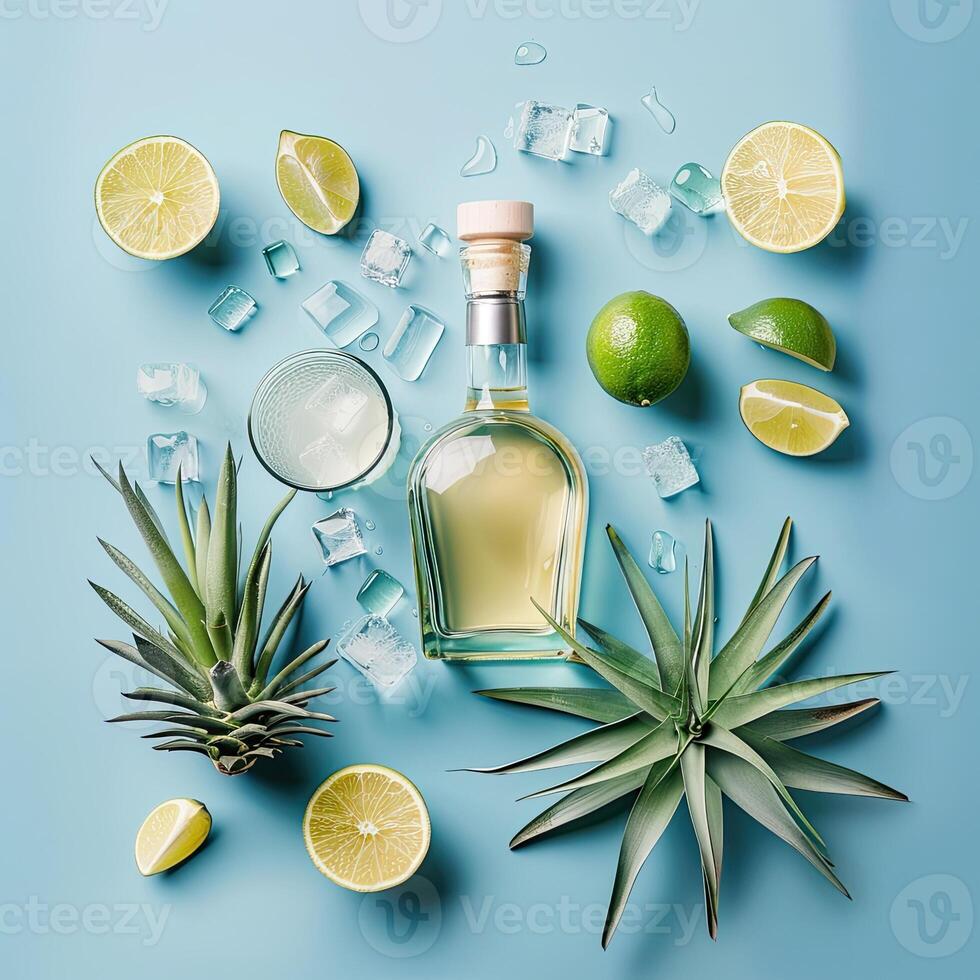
(276, 129), (361, 235)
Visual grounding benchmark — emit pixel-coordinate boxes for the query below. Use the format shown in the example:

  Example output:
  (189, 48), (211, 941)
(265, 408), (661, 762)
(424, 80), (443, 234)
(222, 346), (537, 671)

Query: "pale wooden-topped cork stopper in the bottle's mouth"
(456, 201), (534, 299)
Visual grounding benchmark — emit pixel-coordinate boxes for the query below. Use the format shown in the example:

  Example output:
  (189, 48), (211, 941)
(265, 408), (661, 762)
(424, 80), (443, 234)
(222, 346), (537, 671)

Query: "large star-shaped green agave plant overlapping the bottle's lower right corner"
(470, 518), (908, 948)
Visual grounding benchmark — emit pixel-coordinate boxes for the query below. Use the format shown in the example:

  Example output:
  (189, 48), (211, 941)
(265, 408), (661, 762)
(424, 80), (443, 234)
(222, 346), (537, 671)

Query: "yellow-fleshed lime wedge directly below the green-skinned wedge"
(738, 381), (851, 456)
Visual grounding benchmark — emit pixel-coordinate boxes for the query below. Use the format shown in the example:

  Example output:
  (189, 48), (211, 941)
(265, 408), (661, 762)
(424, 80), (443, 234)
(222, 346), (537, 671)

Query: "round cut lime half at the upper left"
(95, 136), (220, 259)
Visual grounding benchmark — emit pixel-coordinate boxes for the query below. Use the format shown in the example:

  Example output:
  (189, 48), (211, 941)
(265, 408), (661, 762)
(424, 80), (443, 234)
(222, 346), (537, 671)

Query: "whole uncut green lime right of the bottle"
(585, 290), (691, 408)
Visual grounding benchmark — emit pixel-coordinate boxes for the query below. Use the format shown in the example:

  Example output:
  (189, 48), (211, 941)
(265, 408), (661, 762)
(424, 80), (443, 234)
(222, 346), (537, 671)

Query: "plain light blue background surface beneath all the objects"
(0, 0), (980, 980)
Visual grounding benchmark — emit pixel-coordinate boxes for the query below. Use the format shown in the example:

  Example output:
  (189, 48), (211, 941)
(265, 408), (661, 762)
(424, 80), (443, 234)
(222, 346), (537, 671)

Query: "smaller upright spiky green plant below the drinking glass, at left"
(89, 445), (336, 776)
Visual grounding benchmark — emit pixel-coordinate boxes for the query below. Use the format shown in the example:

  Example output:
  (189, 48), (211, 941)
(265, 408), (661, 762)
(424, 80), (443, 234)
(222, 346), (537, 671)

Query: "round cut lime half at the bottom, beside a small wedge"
(303, 765), (430, 892)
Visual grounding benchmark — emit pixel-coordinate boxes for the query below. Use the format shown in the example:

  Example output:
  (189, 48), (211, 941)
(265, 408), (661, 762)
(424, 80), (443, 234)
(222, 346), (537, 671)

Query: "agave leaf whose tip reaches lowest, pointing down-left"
(602, 760), (684, 949)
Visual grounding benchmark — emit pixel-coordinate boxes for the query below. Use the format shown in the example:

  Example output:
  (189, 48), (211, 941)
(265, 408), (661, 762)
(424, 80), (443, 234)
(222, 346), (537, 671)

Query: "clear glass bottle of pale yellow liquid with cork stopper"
(408, 201), (588, 660)
